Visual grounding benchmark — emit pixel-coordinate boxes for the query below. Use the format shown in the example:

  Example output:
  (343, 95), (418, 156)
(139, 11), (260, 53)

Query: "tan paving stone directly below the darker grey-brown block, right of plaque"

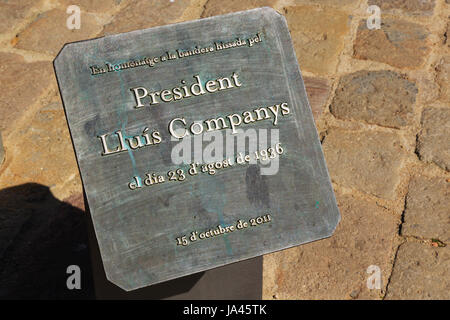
(323, 129), (406, 200)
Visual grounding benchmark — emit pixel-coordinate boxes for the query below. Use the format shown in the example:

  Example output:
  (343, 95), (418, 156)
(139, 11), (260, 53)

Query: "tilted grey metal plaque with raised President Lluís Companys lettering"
(54, 8), (340, 290)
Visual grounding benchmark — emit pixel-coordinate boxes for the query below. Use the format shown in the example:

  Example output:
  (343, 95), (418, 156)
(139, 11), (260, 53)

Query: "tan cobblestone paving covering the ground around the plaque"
(0, 0), (450, 299)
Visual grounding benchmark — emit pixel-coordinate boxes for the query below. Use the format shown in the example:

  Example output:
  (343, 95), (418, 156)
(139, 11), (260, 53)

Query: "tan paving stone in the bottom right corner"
(386, 242), (450, 300)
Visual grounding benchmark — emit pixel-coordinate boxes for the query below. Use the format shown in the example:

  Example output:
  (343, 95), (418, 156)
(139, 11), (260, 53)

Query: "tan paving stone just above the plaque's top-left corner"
(16, 9), (102, 56)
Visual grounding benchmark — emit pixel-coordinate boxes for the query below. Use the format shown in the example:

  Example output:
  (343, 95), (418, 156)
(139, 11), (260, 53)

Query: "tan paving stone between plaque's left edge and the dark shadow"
(0, 92), (80, 196)
